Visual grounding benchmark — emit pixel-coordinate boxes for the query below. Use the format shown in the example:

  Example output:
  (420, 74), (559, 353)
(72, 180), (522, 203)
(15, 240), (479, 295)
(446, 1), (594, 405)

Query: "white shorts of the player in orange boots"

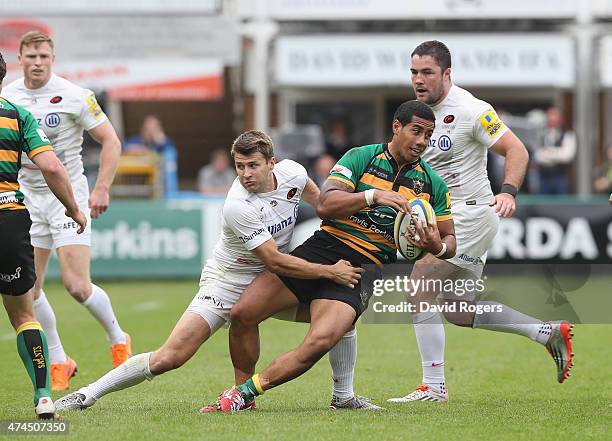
(21, 176), (91, 250)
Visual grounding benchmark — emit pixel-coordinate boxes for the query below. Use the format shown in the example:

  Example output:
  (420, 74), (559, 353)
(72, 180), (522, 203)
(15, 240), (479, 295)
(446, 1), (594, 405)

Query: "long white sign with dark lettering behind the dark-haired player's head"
(276, 33), (575, 88)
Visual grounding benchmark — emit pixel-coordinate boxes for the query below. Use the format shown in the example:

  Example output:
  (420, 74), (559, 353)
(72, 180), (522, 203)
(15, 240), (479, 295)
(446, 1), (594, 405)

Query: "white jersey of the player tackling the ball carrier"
(214, 159), (308, 273)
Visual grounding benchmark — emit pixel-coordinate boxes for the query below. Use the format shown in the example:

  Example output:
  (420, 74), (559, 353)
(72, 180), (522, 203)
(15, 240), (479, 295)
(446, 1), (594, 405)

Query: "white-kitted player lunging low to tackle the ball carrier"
(56, 130), (363, 411)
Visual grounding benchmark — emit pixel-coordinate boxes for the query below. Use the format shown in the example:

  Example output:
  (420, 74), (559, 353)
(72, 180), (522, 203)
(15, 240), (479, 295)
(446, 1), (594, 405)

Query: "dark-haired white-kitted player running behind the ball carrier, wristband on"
(389, 41), (573, 402)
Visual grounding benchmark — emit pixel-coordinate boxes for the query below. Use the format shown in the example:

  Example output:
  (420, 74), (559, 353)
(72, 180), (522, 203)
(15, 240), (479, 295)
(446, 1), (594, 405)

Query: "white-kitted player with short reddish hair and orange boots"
(3, 31), (131, 391)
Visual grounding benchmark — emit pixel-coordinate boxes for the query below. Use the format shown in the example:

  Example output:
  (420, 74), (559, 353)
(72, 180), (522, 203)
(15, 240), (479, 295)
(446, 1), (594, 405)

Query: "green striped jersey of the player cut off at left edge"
(0, 97), (53, 210)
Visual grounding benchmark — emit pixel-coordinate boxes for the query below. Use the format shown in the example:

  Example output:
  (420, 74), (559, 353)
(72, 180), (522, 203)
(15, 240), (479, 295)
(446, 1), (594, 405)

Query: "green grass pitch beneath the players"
(0, 281), (612, 441)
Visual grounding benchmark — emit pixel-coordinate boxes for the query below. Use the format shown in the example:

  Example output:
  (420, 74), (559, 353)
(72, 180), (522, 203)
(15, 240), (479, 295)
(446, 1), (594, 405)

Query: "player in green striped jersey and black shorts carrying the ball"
(213, 101), (456, 412)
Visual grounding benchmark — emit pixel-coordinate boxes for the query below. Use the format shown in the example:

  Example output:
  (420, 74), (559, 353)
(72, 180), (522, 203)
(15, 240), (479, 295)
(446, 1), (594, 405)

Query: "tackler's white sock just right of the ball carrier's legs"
(329, 329), (357, 399)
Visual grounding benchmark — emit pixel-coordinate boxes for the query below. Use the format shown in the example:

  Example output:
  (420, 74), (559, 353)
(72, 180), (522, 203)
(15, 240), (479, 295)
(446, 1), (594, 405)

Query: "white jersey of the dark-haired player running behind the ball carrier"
(422, 85), (508, 203)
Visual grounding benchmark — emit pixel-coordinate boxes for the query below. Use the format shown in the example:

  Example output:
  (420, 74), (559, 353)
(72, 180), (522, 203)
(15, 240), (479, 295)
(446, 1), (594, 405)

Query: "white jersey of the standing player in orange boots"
(2, 74), (108, 189)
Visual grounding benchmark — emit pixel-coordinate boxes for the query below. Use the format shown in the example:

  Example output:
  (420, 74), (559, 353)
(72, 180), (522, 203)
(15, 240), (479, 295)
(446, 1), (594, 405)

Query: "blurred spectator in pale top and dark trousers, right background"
(535, 106), (576, 194)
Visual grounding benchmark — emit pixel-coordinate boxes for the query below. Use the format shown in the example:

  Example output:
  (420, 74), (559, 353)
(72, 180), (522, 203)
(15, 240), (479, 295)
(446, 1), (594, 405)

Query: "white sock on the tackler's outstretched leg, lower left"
(87, 352), (155, 400)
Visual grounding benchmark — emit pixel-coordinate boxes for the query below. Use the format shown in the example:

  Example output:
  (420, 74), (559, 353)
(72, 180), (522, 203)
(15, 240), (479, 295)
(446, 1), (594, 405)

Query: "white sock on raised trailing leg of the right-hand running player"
(472, 301), (552, 345)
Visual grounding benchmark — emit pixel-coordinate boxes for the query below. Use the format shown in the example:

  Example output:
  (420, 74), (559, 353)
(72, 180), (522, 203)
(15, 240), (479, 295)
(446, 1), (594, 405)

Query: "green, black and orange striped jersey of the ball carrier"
(321, 144), (452, 264)
